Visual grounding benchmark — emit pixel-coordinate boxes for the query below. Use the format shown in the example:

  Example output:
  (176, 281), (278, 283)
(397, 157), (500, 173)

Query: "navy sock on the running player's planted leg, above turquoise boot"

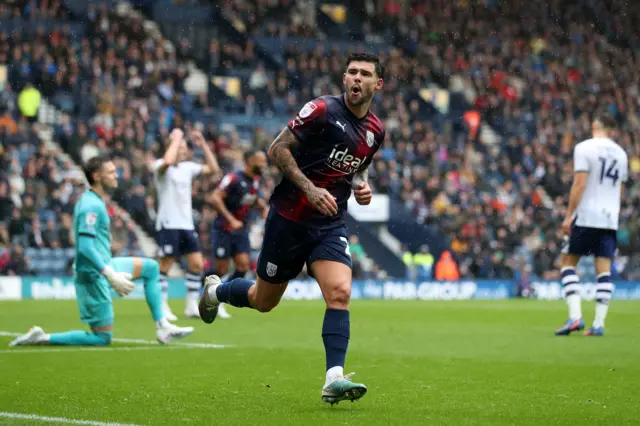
(322, 309), (351, 370)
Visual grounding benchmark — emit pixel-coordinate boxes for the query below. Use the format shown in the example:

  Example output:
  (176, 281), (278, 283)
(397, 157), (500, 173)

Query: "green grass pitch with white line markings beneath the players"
(0, 300), (640, 426)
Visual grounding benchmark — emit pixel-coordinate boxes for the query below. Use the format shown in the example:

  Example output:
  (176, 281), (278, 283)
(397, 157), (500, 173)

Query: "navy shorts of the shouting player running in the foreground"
(256, 210), (352, 284)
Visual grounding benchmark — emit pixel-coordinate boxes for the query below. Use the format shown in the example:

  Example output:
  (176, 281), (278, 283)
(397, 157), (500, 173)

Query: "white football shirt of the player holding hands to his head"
(153, 159), (202, 231)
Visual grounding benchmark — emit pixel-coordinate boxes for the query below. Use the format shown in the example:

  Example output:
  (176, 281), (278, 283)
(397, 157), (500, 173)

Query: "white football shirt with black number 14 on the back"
(573, 138), (629, 230)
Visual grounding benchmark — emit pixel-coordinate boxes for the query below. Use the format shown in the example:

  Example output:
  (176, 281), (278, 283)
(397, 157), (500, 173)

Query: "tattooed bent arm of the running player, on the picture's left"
(268, 128), (338, 216)
